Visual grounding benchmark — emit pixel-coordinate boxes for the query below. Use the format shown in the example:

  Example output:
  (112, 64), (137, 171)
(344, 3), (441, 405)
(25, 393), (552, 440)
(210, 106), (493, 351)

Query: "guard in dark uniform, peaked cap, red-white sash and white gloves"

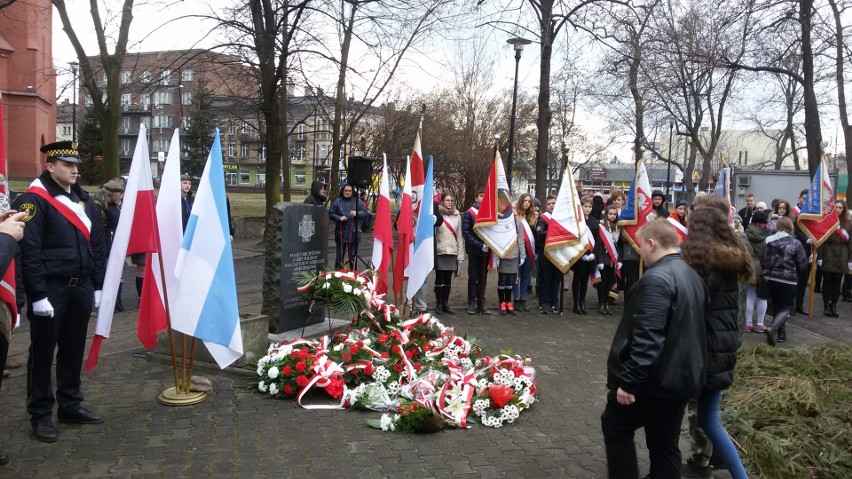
(15, 141), (105, 442)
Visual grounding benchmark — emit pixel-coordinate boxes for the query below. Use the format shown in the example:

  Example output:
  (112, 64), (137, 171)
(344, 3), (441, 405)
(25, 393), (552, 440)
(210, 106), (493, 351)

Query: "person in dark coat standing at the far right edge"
(817, 200), (852, 318)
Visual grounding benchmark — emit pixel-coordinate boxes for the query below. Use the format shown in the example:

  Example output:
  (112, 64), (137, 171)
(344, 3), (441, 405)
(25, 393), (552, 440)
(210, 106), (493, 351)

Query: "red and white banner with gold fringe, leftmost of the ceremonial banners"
(473, 150), (518, 258)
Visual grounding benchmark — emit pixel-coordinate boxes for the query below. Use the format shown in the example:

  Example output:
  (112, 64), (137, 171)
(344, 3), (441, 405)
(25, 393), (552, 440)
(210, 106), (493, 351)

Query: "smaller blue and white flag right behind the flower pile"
(405, 156), (435, 299)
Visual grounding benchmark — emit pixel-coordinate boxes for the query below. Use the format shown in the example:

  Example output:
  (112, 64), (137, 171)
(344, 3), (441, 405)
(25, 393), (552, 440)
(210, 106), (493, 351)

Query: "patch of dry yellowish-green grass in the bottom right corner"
(722, 344), (852, 478)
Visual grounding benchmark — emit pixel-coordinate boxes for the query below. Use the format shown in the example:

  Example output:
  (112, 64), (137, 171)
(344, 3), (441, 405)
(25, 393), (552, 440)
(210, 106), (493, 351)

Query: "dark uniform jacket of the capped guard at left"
(15, 171), (106, 302)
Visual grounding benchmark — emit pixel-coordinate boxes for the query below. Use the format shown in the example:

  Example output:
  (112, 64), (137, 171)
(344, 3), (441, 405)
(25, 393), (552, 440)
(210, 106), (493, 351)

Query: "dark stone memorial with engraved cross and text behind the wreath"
(271, 203), (328, 333)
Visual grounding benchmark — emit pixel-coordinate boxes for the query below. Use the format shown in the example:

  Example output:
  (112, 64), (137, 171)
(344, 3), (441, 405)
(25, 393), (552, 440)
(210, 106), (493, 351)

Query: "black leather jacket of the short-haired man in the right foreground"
(607, 253), (709, 398)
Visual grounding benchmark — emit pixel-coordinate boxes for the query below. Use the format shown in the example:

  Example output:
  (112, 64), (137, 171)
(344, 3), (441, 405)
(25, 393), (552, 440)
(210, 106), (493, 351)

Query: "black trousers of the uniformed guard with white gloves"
(27, 278), (94, 422)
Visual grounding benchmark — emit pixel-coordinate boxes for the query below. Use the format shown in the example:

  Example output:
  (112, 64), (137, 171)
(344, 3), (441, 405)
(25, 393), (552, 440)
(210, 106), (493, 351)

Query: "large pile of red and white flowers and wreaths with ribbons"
(253, 270), (536, 432)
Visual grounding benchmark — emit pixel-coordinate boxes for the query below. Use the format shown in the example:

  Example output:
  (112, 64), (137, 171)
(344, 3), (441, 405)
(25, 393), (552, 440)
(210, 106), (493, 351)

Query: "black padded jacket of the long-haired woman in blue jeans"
(704, 276), (745, 391)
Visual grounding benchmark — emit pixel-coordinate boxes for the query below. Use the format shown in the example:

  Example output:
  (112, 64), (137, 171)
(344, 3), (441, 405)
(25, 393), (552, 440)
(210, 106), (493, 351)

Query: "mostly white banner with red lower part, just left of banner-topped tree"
(544, 165), (590, 274)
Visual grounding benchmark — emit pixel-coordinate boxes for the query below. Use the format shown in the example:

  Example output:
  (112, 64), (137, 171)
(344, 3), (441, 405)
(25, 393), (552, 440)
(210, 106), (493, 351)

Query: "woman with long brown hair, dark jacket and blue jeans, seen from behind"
(681, 208), (754, 479)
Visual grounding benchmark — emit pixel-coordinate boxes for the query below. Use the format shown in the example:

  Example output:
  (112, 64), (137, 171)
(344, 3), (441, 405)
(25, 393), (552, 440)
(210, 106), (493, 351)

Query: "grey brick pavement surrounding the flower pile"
(0, 235), (850, 478)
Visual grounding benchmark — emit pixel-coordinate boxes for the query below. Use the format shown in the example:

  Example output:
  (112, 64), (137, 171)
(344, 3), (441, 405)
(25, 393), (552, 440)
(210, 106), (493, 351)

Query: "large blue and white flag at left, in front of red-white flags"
(170, 128), (243, 369)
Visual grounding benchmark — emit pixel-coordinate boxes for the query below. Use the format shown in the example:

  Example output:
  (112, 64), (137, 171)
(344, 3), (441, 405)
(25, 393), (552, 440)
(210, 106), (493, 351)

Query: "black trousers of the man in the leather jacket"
(601, 391), (688, 479)
